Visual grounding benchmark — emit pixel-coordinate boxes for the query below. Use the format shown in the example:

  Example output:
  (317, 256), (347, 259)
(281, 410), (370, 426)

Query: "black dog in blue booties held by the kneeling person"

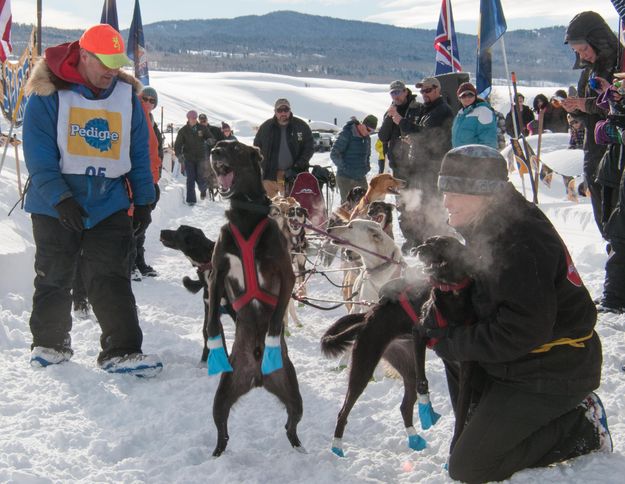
(321, 237), (474, 457)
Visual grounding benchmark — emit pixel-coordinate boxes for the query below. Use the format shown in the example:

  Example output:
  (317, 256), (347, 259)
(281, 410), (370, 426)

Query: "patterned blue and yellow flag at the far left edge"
(0, 27), (35, 128)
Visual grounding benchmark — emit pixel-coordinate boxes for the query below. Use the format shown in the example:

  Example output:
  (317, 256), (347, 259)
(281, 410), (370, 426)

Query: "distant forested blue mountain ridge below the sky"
(8, 11), (578, 85)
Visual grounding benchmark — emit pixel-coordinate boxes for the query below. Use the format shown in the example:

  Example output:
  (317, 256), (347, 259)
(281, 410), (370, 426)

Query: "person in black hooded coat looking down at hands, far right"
(562, 12), (620, 235)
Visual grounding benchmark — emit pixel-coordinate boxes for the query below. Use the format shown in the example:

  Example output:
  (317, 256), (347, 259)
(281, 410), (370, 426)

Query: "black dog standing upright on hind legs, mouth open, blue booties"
(205, 141), (305, 456)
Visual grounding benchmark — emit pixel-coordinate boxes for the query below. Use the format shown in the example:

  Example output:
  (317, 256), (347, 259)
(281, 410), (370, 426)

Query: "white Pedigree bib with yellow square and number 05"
(57, 82), (132, 178)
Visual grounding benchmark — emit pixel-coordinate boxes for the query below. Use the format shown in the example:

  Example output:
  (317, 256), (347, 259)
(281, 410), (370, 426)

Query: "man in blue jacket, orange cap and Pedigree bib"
(23, 24), (163, 376)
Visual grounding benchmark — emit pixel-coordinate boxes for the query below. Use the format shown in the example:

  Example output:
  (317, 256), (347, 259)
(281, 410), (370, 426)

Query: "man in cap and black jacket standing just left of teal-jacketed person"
(388, 77), (454, 253)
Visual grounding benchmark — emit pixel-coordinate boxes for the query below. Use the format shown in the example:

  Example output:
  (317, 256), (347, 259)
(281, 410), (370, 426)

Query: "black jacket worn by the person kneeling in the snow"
(435, 185), (602, 395)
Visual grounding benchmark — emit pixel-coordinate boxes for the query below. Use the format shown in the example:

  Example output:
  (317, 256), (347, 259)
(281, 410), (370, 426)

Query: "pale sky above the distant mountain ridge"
(11, 0), (617, 34)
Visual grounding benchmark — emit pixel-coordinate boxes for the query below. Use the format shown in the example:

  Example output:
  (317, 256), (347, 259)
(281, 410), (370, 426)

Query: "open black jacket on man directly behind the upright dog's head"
(254, 114), (315, 181)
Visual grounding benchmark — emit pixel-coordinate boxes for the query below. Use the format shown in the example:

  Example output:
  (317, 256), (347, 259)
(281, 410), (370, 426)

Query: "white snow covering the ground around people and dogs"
(0, 72), (625, 484)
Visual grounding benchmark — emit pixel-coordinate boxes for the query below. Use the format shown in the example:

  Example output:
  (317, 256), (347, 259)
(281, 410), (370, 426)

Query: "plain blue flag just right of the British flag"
(475, 0), (508, 98)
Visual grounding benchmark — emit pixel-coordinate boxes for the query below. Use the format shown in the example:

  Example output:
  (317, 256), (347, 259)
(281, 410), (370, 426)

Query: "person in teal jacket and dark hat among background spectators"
(451, 82), (498, 149)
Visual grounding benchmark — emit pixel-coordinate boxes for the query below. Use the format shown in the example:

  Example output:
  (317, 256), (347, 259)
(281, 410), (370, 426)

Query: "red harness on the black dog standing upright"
(229, 218), (278, 312)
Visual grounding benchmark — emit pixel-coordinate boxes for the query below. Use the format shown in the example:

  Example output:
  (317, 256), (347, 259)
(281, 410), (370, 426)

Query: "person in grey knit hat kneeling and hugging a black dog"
(426, 145), (612, 482)
